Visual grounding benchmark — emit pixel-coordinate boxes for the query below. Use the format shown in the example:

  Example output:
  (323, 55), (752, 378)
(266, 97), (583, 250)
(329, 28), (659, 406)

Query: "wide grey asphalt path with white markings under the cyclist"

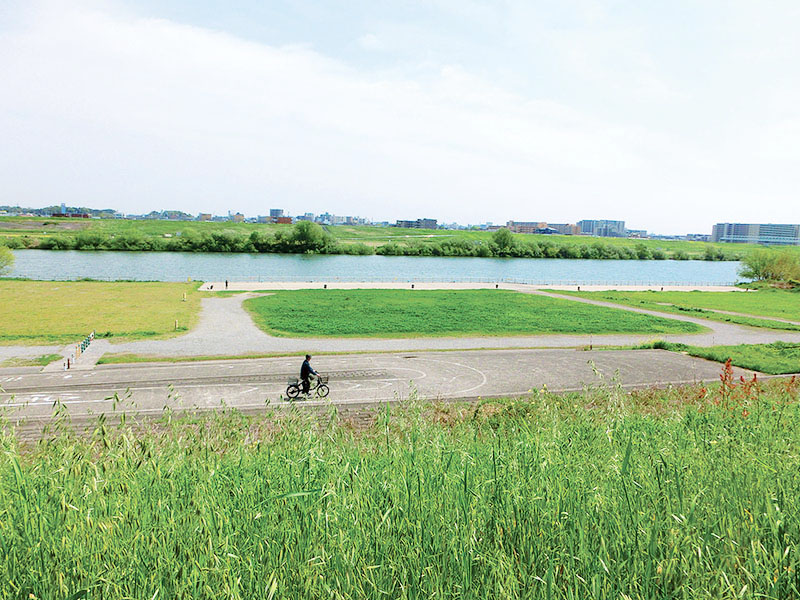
(0, 349), (751, 435)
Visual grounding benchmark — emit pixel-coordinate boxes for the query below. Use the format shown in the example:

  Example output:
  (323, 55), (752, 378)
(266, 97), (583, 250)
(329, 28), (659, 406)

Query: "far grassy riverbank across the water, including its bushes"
(0, 217), (756, 260)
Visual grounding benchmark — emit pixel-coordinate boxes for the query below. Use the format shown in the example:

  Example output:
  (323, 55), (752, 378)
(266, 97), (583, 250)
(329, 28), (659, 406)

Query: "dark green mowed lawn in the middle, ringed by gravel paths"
(244, 290), (703, 337)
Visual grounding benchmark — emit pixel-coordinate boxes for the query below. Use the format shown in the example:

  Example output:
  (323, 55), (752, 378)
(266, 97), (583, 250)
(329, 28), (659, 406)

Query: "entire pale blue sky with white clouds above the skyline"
(0, 0), (800, 234)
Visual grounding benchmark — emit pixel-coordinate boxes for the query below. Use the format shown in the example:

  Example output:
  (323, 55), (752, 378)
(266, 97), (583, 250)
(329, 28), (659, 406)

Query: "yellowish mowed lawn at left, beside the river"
(0, 280), (201, 345)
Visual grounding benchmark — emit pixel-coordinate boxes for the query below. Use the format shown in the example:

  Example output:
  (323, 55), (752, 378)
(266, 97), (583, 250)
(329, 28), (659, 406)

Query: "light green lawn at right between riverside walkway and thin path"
(556, 289), (800, 322)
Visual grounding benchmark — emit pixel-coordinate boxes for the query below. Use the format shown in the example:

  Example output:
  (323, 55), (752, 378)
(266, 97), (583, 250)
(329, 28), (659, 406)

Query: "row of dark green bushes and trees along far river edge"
(0, 221), (741, 261)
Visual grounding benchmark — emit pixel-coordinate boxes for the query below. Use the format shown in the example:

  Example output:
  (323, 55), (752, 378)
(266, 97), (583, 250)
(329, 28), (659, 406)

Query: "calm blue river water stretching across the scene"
(9, 250), (739, 285)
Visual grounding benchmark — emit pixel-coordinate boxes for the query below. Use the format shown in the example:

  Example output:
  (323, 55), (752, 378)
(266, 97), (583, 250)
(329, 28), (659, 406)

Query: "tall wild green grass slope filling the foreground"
(0, 381), (800, 599)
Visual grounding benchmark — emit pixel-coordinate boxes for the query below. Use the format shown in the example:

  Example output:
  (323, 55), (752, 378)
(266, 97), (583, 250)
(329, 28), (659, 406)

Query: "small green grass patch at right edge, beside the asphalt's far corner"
(637, 341), (800, 375)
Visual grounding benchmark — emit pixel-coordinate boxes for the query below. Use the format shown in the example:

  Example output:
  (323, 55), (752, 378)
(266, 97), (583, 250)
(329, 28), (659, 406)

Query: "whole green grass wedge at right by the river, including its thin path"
(552, 289), (800, 331)
